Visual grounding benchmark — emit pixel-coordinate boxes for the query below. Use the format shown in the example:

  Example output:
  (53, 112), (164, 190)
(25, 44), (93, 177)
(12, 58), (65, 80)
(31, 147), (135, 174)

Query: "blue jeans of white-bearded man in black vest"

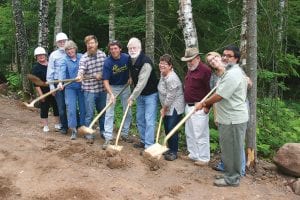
(136, 92), (158, 148)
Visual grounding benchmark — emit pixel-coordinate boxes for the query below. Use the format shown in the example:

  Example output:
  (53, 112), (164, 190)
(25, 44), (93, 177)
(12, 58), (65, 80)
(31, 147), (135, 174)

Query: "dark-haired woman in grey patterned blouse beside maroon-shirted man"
(158, 54), (185, 161)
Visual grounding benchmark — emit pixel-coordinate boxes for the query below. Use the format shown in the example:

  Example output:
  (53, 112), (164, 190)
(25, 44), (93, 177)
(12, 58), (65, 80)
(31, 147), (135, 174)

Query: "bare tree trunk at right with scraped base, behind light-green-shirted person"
(246, 0), (257, 167)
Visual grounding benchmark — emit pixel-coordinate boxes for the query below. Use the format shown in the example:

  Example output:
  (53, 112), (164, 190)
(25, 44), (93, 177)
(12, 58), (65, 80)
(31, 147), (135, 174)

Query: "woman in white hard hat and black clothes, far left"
(32, 47), (60, 133)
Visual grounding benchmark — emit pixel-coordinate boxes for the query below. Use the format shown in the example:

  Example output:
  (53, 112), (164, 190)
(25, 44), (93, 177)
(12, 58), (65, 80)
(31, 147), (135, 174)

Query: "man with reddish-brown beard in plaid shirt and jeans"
(77, 35), (106, 142)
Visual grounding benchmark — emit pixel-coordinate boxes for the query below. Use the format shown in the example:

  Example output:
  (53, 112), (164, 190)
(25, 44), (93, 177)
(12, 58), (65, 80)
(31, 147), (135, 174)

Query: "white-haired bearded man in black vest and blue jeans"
(127, 37), (158, 148)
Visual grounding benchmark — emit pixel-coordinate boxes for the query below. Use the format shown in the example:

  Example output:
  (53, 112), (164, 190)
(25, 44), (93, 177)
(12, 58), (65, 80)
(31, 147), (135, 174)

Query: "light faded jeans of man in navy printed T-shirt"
(104, 85), (131, 140)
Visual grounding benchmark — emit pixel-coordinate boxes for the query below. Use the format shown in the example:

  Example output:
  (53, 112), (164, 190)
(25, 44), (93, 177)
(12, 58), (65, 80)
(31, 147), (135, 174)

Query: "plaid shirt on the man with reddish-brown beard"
(78, 50), (106, 93)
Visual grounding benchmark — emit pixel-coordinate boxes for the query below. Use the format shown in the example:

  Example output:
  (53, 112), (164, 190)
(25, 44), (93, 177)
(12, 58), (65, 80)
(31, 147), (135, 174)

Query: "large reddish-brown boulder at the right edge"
(273, 143), (300, 177)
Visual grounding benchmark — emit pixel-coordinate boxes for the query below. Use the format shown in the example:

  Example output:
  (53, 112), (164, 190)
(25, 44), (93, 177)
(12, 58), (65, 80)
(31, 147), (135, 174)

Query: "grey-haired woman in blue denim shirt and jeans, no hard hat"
(58, 40), (85, 140)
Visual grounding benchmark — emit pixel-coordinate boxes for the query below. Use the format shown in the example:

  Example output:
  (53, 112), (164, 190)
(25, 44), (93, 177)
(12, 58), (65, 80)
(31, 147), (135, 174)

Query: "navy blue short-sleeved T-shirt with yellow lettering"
(102, 53), (129, 85)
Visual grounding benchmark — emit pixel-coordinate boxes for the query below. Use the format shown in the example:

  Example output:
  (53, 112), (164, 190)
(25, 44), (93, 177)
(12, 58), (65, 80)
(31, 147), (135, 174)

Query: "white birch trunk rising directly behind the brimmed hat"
(178, 0), (198, 48)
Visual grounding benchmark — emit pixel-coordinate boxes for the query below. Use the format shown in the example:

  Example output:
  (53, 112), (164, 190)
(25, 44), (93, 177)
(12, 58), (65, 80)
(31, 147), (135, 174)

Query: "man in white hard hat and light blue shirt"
(47, 33), (68, 134)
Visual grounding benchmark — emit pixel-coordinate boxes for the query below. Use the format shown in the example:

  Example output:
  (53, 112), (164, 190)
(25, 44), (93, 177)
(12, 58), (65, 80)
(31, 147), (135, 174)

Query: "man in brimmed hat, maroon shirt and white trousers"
(181, 48), (211, 166)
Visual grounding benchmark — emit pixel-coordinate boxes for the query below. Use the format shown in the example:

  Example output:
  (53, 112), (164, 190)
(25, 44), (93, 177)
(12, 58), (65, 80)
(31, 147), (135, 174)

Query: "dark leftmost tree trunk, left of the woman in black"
(12, 0), (30, 98)
